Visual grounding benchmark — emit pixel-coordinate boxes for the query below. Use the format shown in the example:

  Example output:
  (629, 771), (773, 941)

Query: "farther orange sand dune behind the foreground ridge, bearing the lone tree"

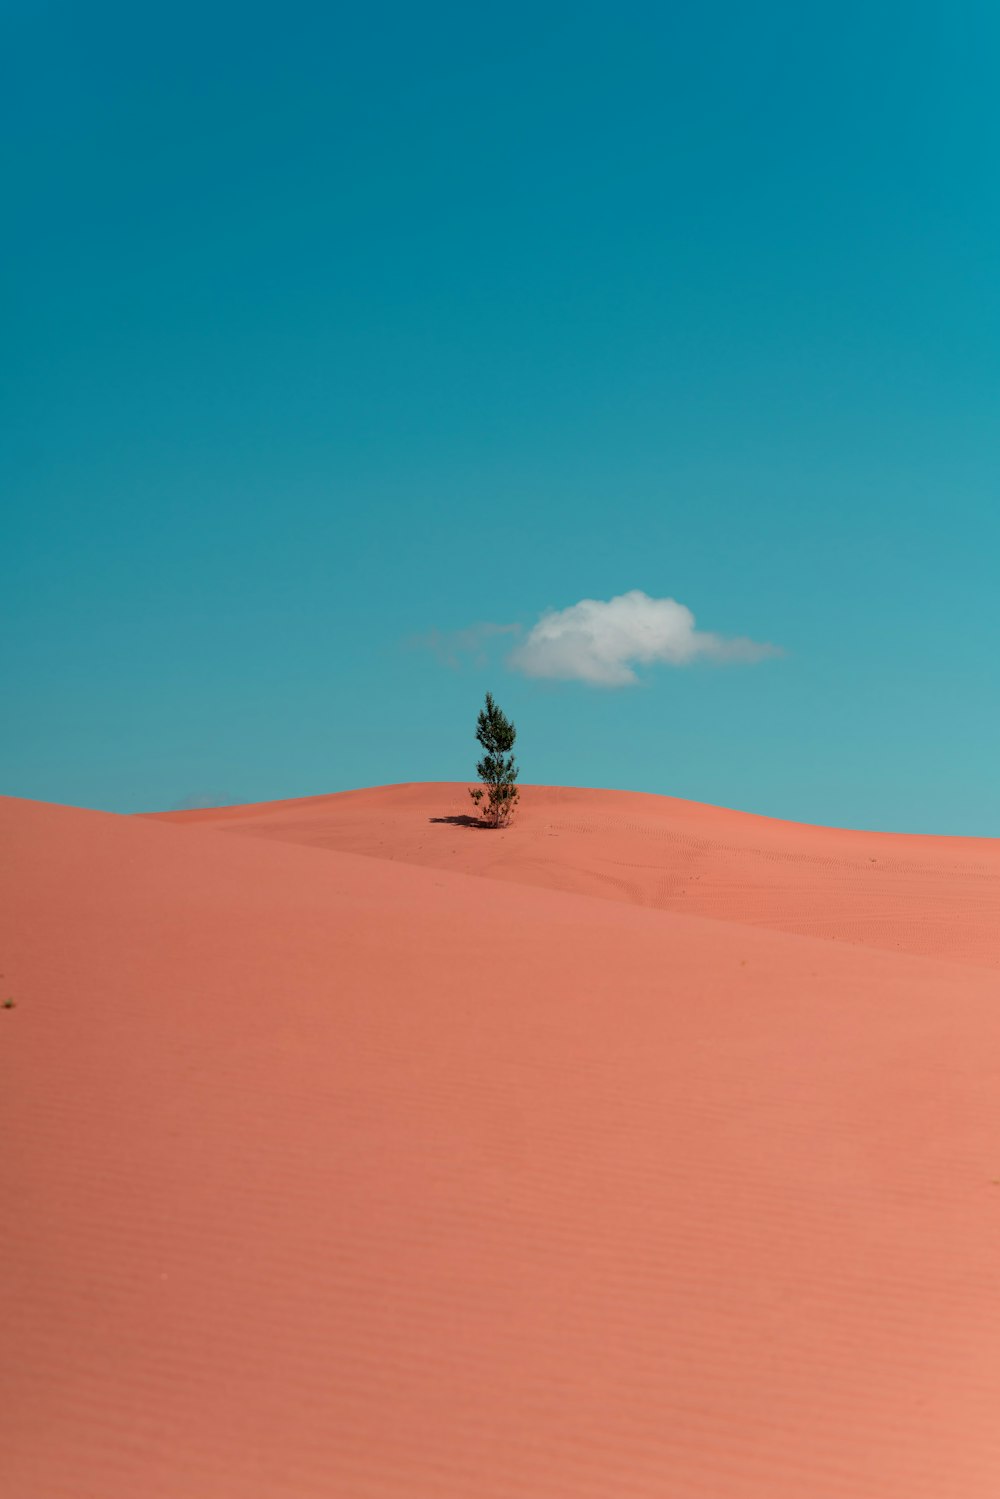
(156, 782), (1000, 968)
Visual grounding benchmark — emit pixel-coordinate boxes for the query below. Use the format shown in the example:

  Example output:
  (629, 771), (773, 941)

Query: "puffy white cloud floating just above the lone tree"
(508, 589), (781, 687)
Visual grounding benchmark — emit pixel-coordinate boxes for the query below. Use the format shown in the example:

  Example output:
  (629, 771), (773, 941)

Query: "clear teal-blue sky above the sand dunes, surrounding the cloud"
(0, 0), (1000, 835)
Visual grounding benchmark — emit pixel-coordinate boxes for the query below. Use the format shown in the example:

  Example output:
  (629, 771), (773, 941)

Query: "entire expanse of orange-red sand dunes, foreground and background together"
(0, 785), (1000, 1499)
